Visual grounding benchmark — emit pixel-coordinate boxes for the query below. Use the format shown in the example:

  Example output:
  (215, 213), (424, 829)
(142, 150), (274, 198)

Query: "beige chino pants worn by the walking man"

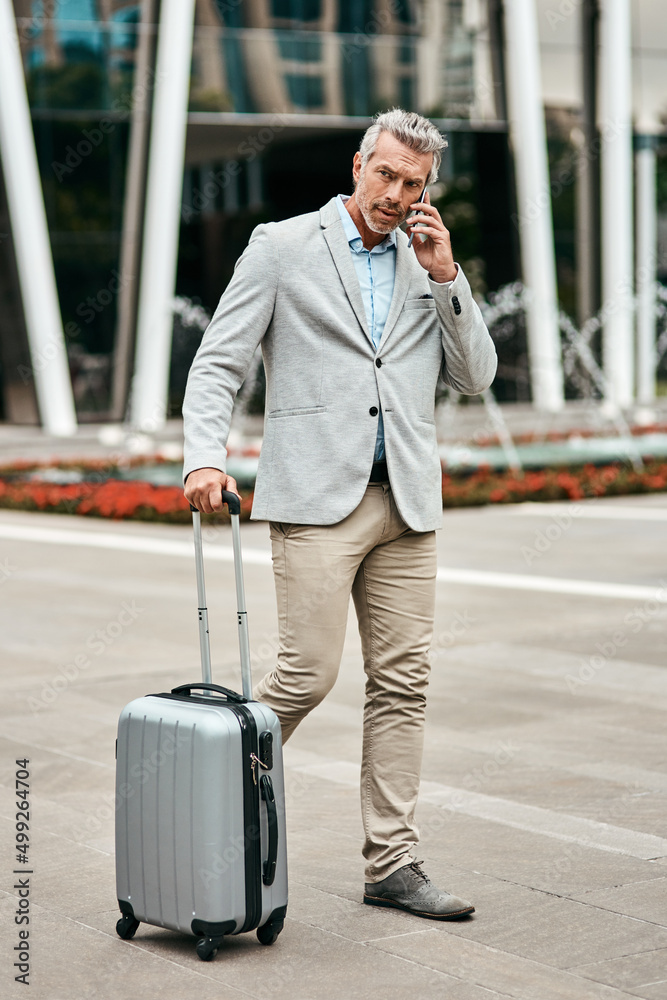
(254, 483), (436, 882)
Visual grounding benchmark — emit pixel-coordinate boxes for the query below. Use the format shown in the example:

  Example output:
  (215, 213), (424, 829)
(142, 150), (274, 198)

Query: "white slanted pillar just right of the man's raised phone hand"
(505, 0), (563, 412)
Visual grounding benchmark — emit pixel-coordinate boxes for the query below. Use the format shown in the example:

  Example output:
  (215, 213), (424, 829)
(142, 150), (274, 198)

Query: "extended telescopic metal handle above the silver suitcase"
(190, 490), (252, 701)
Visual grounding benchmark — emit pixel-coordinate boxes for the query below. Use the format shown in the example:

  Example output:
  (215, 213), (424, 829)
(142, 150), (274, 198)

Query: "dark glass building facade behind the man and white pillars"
(7, 0), (667, 423)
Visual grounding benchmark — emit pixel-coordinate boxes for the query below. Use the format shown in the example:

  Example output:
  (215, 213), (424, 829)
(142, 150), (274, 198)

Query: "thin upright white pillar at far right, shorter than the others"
(635, 134), (658, 406)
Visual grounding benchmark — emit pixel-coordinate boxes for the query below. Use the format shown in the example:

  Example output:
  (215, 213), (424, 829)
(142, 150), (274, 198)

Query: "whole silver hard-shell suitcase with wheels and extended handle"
(116, 492), (287, 961)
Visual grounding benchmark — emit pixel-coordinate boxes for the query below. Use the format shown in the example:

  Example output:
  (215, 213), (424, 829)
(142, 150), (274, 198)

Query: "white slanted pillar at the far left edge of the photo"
(0, 0), (76, 437)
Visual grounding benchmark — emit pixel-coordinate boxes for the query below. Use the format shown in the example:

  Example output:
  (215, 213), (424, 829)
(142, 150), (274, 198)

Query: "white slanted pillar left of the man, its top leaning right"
(131, 0), (195, 433)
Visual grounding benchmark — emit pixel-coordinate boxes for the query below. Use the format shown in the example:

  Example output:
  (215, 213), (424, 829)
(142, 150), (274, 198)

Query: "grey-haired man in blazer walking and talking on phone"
(183, 108), (496, 920)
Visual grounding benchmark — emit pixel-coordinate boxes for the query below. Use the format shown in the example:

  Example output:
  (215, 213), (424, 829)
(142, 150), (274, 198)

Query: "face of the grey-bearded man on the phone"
(353, 132), (433, 233)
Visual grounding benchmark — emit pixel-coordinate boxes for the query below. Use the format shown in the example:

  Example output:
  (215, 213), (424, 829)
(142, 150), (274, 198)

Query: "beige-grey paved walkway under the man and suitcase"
(0, 496), (667, 1000)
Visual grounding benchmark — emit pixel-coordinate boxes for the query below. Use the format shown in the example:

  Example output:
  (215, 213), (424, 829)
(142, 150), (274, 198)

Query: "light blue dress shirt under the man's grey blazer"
(336, 194), (396, 462)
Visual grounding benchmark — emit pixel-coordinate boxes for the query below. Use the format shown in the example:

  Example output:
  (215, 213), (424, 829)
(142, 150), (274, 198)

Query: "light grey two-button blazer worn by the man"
(183, 199), (496, 531)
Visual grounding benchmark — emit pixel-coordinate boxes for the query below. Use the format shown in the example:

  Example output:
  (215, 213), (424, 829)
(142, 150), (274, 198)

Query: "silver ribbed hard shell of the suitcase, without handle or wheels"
(116, 695), (287, 933)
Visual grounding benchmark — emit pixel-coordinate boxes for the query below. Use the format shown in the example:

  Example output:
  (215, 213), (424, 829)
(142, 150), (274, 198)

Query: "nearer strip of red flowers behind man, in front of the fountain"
(0, 460), (667, 524)
